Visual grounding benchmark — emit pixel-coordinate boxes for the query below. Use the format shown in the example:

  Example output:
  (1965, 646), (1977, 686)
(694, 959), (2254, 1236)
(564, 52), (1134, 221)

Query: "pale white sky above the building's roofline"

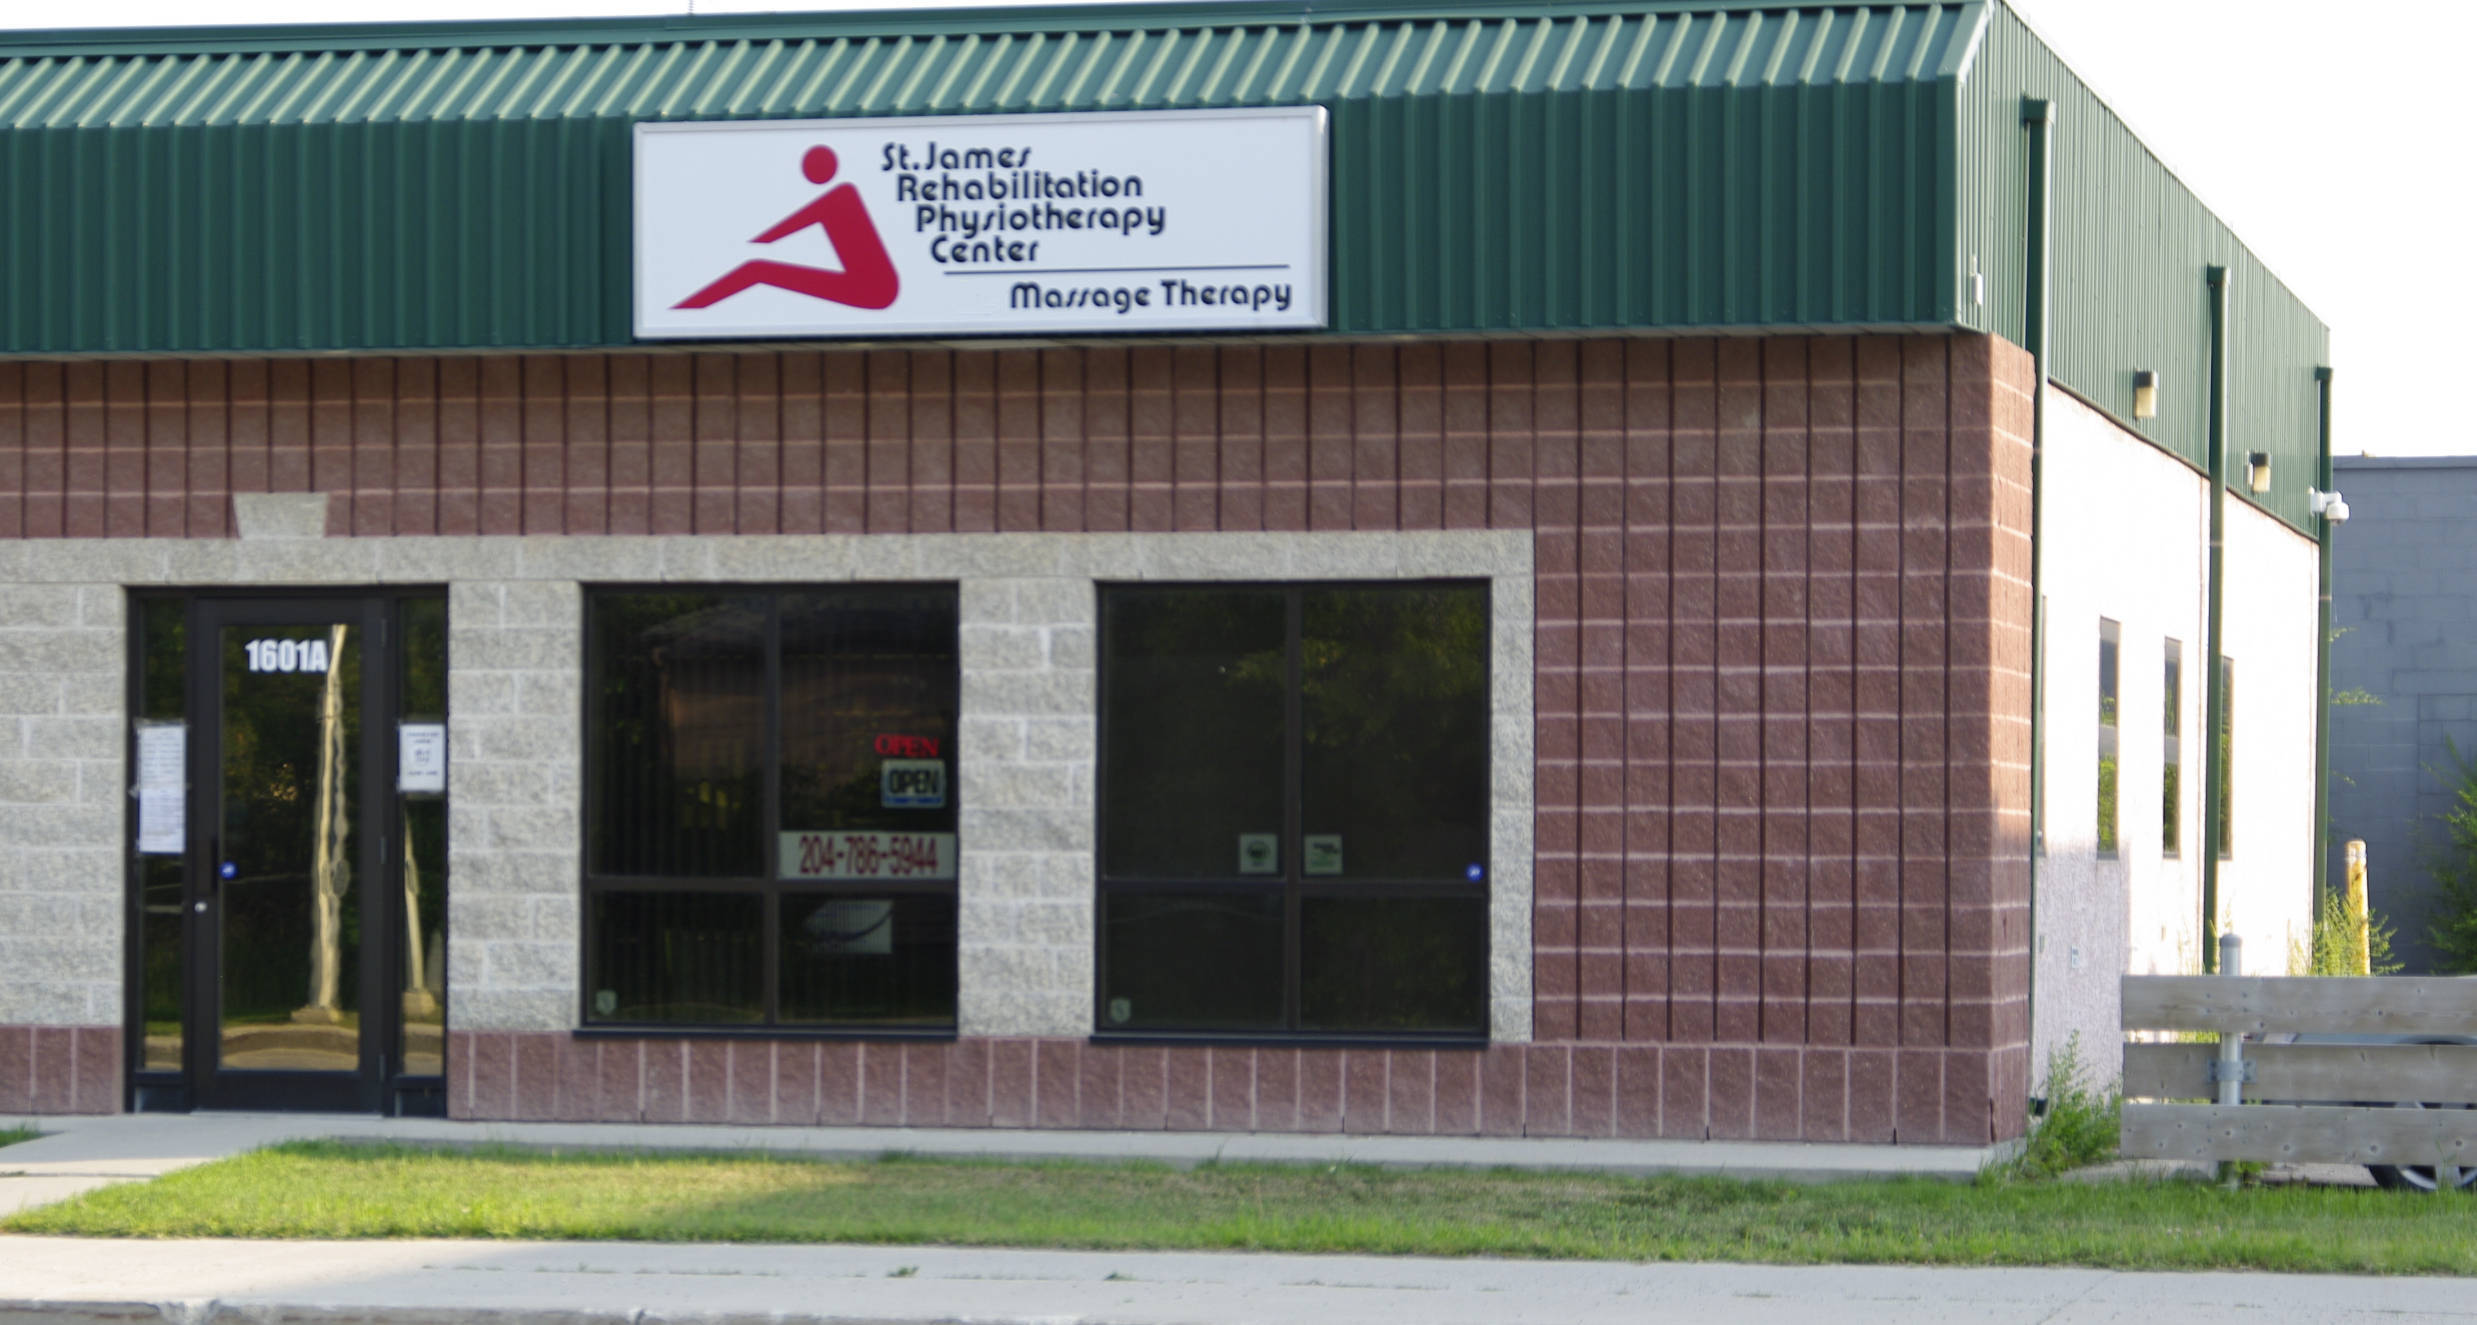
(0, 0), (2477, 456)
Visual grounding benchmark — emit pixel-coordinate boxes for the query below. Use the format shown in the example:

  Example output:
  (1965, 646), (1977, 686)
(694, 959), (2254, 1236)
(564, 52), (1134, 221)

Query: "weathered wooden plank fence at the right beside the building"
(2123, 976), (2477, 1184)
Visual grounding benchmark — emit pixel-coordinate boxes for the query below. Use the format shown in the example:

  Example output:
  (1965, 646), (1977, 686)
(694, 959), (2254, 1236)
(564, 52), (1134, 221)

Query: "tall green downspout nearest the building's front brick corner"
(2021, 97), (2056, 1035)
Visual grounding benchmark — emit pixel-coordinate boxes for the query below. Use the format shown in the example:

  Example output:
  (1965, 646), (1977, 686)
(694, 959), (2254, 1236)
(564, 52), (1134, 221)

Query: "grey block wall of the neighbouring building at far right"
(2328, 456), (2477, 971)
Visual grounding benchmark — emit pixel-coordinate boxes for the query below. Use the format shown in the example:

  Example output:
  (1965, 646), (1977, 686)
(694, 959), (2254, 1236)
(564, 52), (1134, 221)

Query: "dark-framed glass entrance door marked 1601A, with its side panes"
(134, 594), (446, 1112)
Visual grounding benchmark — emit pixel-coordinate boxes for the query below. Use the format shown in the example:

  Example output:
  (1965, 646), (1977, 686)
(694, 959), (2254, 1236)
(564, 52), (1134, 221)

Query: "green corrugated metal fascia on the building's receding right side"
(1952, 7), (2331, 532)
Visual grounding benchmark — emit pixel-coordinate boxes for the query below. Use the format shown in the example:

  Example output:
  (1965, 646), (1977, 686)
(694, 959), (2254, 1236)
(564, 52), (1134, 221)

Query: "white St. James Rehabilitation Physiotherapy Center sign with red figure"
(637, 106), (1325, 339)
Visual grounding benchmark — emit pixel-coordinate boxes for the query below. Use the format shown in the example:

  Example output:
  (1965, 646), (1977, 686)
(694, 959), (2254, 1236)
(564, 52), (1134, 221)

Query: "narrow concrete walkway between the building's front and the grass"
(0, 1112), (2009, 1214)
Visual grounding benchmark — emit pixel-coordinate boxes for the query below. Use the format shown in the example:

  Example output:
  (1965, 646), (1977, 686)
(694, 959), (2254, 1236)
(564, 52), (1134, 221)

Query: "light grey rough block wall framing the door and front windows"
(0, 527), (1533, 1043)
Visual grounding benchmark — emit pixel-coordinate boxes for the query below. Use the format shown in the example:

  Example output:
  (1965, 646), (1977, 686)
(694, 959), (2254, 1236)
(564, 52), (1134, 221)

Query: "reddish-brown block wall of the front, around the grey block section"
(0, 337), (2031, 1142)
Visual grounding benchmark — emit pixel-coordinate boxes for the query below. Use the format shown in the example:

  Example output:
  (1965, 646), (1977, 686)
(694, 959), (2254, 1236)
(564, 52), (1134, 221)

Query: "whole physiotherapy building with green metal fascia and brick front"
(0, 0), (2326, 1144)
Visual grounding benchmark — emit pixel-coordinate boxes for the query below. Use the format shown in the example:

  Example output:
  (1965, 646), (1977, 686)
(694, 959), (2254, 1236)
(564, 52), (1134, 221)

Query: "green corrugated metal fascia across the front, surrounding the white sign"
(0, 0), (1989, 354)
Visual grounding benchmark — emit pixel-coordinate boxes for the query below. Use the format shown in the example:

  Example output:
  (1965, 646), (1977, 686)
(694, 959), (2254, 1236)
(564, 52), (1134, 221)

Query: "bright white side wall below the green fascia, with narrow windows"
(2031, 386), (2316, 1077)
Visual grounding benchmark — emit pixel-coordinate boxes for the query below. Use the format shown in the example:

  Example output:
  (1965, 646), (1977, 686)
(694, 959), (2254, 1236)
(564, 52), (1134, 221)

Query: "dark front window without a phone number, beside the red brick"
(1095, 582), (1491, 1038)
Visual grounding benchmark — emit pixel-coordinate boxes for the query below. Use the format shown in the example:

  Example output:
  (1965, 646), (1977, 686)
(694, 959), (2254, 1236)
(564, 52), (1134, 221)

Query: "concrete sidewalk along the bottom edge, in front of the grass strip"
(0, 1238), (2477, 1325)
